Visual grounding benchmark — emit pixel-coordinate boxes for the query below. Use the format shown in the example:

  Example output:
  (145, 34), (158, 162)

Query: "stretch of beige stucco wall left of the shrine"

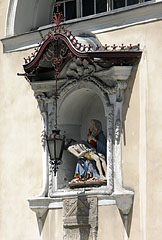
(0, 43), (42, 240)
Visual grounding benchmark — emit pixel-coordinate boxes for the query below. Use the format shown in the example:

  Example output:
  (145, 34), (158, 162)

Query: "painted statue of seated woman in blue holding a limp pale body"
(68, 119), (107, 183)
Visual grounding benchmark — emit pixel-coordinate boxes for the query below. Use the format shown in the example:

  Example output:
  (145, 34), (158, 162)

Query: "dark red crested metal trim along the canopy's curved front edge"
(23, 25), (142, 72)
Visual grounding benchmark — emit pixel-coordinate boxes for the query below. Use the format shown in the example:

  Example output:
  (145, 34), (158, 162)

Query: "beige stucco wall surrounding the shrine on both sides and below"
(0, 0), (162, 240)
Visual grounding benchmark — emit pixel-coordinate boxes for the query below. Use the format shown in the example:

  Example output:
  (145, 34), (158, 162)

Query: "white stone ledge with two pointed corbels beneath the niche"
(28, 189), (134, 234)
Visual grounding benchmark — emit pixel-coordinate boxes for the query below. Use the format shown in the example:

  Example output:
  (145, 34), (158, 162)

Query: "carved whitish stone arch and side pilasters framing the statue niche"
(31, 63), (132, 197)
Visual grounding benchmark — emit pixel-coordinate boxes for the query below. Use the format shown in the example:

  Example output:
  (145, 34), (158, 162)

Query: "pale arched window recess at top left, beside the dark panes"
(6, 0), (55, 36)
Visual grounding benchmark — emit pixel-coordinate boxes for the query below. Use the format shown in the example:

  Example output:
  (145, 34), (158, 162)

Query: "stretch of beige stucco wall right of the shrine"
(98, 21), (162, 240)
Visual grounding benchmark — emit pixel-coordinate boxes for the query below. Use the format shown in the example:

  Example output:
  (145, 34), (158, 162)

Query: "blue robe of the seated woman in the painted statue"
(75, 131), (106, 179)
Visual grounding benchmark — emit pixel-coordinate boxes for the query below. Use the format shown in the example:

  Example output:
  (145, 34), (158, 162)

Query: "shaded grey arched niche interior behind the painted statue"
(55, 87), (107, 190)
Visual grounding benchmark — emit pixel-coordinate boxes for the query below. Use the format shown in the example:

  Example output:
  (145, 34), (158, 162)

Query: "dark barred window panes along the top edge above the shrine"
(54, 0), (151, 20)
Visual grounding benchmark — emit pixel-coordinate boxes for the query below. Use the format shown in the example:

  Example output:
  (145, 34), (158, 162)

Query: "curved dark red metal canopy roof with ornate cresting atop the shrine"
(24, 13), (141, 87)
